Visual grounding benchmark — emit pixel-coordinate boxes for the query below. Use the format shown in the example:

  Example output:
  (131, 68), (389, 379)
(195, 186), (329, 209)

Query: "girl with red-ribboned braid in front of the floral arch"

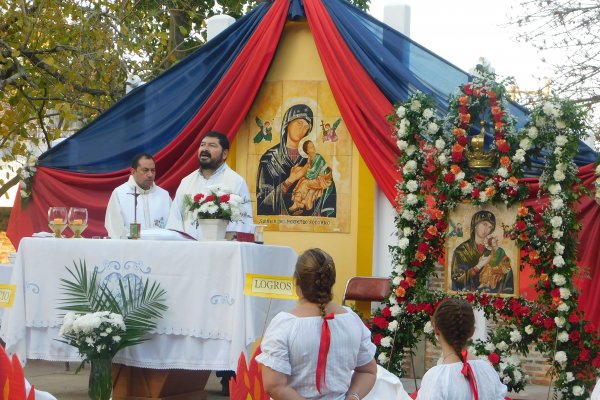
(417, 299), (507, 400)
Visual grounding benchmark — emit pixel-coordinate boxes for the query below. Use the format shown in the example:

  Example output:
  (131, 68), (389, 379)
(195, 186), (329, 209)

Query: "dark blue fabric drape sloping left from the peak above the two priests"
(39, 2), (272, 173)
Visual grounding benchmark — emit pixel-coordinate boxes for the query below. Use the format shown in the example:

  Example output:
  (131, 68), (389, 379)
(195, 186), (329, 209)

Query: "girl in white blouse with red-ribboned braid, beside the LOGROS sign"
(256, 249), (377, 400)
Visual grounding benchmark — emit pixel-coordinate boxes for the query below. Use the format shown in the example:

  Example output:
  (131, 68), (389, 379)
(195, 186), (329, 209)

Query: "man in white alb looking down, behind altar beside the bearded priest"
(104, 153), (171, 239)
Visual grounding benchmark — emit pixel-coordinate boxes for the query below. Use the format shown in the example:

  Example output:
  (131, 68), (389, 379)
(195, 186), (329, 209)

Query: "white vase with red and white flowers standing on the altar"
(183, 185), (247, 240)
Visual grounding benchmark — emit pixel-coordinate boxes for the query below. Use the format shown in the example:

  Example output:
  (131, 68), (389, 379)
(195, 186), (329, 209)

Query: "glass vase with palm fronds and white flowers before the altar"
(60, 262), (167, 400)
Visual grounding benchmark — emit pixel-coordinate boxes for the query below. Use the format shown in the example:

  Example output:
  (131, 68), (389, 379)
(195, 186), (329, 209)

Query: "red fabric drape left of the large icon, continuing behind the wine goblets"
(7, 0), (289, 247)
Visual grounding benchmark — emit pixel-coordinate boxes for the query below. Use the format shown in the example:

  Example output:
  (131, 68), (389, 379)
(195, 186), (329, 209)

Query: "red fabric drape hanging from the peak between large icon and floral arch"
(304, 0), (399, 203)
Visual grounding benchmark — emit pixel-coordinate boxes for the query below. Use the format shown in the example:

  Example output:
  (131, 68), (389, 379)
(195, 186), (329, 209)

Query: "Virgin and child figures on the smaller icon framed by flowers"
(450, 210), (515, 294)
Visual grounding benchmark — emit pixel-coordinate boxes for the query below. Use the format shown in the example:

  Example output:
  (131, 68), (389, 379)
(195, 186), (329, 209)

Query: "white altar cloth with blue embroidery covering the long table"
(0, 238), (297, 370)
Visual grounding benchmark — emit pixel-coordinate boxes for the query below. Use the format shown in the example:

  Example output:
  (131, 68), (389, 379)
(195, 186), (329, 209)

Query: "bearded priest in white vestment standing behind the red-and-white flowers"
(167, 131), (254, 239)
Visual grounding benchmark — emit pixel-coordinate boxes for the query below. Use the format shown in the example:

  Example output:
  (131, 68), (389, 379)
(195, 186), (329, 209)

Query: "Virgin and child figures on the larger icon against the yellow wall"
(256, 104), (336, 218)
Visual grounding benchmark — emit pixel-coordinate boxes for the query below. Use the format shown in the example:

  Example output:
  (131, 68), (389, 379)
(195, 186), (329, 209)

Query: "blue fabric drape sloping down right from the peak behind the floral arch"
(323, 0), (597, 170)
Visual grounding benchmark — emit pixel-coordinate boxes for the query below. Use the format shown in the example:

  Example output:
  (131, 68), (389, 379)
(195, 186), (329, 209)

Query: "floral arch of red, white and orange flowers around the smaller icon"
(371, 66), (600, 399)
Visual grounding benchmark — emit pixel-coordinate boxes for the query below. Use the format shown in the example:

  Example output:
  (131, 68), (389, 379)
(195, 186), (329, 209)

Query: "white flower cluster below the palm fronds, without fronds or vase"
(59, 311), (126, 360)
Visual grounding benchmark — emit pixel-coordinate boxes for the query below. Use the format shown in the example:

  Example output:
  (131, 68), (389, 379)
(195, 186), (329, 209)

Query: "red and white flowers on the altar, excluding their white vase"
(183, 185), (247, 226)
